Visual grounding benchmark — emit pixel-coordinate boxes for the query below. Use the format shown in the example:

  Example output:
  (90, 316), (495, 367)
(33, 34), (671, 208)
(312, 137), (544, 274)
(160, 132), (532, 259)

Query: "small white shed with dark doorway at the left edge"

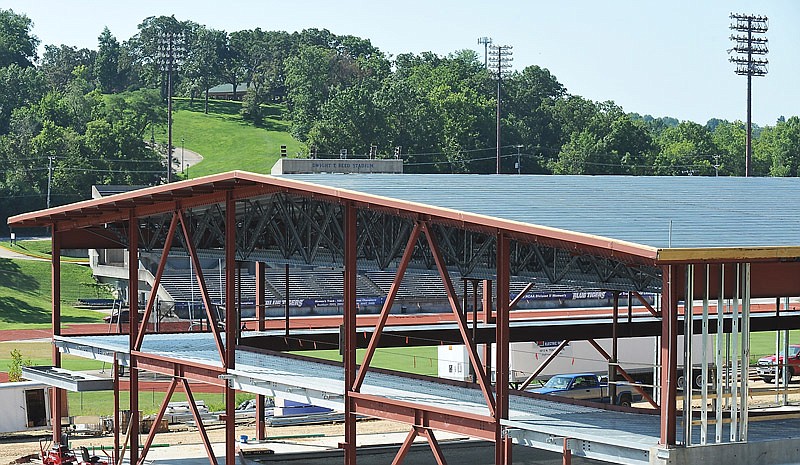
(0, 381), (50, 433)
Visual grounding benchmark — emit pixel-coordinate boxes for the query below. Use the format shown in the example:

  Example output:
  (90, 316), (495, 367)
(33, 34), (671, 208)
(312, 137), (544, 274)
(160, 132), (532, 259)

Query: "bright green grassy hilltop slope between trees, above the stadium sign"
(158, 99), (303, 178)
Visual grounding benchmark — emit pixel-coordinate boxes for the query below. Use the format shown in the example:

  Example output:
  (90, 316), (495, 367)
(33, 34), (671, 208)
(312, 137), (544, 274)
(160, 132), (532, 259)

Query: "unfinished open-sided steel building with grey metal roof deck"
(8, 171), (800, 465)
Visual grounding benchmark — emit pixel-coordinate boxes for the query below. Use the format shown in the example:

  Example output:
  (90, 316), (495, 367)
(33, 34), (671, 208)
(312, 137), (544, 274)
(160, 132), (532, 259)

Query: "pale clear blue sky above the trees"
(0, 0), (800, 125)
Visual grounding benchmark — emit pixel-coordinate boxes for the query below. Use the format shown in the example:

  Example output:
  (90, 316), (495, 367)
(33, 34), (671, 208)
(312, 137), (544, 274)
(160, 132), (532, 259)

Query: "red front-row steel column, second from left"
(128, 210), (139, 463)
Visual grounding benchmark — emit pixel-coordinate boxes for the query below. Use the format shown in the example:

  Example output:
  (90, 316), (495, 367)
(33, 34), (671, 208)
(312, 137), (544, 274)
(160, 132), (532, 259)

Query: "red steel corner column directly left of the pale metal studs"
(659, 265), (678, 446)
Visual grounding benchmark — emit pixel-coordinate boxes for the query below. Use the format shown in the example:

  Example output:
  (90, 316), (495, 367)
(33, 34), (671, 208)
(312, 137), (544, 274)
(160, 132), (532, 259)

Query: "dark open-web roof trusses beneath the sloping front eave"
(104, 193), (662, 292)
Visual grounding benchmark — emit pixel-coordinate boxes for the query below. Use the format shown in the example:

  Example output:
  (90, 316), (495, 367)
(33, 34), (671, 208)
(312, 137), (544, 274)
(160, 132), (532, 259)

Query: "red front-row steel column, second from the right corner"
(494, 233), (511, 465)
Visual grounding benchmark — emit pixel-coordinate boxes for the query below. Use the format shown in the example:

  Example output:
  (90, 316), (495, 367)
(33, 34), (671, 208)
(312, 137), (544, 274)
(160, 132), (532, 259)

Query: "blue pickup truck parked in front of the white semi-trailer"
(533, 373), (642, 407)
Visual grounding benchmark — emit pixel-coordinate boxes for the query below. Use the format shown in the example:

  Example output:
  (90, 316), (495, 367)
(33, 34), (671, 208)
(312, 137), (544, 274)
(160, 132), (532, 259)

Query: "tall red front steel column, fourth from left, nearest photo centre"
(341, 204), (358, 465)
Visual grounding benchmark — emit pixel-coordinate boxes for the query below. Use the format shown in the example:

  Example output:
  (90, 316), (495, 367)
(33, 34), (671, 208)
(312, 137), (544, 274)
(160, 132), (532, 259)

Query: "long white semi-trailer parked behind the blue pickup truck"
(438, 335), (714, 384)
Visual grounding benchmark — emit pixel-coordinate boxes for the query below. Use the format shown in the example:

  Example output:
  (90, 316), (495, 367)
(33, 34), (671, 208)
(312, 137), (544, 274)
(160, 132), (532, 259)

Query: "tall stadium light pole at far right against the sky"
(728, 13), (769, 176)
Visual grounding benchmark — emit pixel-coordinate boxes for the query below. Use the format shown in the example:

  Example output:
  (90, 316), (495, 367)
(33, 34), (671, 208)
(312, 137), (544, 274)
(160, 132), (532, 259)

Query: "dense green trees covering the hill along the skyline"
(0, 9), (800, 228)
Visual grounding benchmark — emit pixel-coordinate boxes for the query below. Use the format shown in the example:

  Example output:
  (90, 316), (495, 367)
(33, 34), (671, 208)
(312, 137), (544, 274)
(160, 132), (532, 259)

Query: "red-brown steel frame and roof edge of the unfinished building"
(9, 172), (800, 465)
